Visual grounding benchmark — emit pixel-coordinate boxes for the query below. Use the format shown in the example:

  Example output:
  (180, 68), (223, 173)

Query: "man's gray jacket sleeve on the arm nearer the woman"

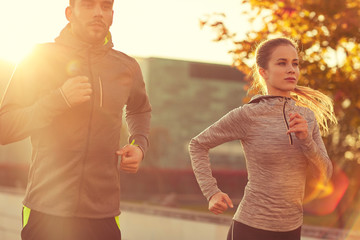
(126, 60), (151, 155)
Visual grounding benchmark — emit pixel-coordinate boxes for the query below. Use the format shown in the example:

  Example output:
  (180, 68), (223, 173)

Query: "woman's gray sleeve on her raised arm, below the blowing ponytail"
(300, 112), (333, 183)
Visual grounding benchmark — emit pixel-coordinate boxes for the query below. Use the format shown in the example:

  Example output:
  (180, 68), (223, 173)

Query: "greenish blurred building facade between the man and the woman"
(139, 58), (246, 169)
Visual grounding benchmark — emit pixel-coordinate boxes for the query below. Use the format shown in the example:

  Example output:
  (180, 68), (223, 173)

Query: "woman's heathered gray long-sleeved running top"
(189, 96), (333, 231)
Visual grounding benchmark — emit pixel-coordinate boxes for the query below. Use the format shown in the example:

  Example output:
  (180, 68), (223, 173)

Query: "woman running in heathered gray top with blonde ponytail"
(189, 37), (337, 240)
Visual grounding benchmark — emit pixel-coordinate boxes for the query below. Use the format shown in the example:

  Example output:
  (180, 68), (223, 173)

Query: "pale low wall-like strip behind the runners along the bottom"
(0, 189), (360, 240)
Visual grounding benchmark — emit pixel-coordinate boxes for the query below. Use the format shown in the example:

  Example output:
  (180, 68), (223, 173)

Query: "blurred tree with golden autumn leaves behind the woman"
(200, 0), (360, 229)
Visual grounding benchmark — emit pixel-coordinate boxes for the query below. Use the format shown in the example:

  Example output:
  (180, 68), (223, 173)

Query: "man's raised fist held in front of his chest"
(60, 76), (92, 107)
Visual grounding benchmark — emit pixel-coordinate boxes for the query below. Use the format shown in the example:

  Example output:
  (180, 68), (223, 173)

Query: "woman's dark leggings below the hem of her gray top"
(227, 221), (301, 240)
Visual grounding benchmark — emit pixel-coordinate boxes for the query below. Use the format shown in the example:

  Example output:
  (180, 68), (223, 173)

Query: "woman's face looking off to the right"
(259, 45), (299, 97)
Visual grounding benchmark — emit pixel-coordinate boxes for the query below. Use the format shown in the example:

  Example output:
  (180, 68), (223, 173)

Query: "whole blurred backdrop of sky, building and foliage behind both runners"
(0, 0), (360, 240)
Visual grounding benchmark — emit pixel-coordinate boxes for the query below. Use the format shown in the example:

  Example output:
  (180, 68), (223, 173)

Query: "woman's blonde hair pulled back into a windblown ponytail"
(249, 37), (337, 135)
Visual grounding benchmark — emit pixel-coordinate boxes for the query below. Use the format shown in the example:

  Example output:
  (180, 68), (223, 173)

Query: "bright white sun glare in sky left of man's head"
(0, 0), (68, 63)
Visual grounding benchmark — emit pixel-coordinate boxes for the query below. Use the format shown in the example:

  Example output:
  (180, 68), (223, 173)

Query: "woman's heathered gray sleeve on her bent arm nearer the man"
(189, 108), (247, 201)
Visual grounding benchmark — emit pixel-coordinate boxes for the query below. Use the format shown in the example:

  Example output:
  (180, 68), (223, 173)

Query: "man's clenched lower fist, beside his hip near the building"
(116, 144), (144, 173)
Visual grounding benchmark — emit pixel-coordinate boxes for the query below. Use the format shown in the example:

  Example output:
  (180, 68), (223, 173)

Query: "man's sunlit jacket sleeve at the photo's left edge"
(0, 50), (68, 144)
